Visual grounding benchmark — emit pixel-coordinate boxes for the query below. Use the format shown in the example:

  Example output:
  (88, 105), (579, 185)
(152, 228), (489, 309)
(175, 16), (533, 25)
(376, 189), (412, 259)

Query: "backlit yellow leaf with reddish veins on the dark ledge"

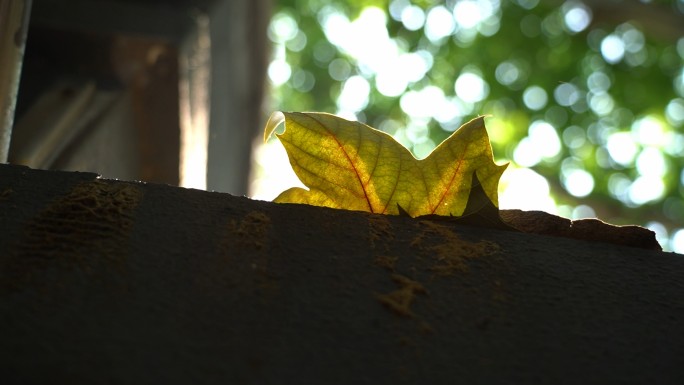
(264, 112), (507, 217)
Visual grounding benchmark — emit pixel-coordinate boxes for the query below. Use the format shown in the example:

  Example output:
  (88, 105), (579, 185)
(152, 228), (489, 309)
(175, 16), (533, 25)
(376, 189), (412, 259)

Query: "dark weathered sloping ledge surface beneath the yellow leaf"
(0, 165), (684, 384)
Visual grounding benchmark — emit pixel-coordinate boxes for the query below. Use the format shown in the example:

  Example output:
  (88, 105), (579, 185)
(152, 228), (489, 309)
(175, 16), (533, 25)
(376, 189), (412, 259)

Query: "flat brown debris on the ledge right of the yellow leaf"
(499, 210), (662, 251)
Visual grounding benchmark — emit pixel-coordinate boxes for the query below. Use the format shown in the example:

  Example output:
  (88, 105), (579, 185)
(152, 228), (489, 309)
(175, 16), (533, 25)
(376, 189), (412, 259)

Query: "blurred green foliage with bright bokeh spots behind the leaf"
(269, 0), (684, 252)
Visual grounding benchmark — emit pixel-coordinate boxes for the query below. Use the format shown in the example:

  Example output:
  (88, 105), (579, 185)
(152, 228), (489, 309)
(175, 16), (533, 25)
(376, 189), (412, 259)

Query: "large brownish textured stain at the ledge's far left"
(0, 180), (143, 289)
